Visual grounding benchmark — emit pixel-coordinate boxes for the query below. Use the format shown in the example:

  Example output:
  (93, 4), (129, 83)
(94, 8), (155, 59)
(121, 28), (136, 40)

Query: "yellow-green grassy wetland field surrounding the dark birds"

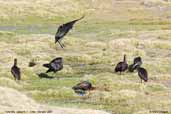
(0, 0), (171, 114)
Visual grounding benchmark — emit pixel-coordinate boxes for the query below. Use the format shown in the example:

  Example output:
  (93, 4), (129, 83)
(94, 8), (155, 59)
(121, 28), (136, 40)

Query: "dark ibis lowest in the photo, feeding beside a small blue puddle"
(72, 81), (95, 95)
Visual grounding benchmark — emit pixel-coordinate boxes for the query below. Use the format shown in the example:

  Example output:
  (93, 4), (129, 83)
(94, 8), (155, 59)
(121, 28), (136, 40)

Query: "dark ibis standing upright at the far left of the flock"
(11, 58), (21, 80)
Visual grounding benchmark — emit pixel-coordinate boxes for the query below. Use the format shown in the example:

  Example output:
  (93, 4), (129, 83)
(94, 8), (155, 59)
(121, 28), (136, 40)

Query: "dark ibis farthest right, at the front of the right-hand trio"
(137, 65), (148, 83)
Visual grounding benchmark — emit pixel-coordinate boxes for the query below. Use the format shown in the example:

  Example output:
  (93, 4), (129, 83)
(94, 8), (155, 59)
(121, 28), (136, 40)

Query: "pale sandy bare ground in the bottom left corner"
(0, 87), (108, 114)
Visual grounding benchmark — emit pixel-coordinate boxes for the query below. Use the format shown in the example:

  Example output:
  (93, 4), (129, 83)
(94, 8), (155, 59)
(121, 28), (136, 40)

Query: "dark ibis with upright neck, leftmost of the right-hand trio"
(115, 55), (128, 74)
